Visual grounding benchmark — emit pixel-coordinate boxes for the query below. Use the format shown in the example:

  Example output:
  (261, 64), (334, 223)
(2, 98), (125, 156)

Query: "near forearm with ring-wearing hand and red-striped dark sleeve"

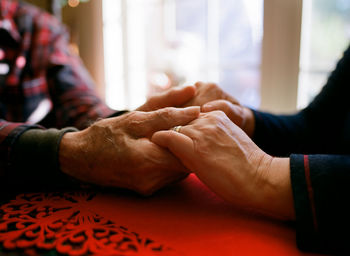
(152, 111), (350, 254)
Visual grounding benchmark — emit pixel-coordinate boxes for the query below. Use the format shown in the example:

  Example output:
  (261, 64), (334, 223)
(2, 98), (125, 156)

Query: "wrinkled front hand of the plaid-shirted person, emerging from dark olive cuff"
(59, 107), (199, 195)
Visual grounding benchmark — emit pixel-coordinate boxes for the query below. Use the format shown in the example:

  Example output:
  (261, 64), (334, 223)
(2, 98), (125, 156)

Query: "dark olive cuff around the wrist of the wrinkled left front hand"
(6, 128), (77, 190)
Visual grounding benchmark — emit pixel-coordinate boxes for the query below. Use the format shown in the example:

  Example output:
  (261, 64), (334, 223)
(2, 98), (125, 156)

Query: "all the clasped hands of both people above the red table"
(60, 83), (294, 219)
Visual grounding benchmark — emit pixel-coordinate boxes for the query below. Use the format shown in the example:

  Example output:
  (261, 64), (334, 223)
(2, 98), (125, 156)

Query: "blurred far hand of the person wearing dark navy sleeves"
(185, 82), (255, 137)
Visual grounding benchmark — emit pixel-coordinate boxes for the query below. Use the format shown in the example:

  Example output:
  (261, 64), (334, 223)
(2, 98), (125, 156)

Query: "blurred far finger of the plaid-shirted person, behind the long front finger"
(137, 86), (196, 111)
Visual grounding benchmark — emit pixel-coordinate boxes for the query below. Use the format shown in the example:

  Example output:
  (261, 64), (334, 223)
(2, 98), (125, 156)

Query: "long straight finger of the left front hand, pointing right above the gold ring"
(129, 107), (200, 136)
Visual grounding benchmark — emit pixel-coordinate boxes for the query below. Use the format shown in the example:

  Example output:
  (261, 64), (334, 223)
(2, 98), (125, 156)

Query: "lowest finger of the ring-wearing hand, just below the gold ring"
(151, 131), (196, 170)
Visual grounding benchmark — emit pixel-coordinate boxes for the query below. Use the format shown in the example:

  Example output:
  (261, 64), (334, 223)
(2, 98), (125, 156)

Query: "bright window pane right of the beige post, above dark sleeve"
(298, 0), (350, 108)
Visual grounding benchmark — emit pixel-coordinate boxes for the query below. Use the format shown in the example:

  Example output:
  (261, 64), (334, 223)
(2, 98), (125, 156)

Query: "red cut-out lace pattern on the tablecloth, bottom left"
(0, 192), (174, 256)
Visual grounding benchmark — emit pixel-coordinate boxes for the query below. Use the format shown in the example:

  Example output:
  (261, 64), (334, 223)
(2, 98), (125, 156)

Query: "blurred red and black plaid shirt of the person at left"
(0, 0), (113, 174)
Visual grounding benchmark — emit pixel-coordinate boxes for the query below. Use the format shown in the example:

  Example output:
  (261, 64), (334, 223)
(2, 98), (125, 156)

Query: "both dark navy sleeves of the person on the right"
(253, 43), (350, 254)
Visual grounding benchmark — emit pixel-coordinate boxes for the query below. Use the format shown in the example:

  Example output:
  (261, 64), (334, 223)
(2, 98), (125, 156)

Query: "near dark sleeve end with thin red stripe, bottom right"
(290, 155), (350, 255)
